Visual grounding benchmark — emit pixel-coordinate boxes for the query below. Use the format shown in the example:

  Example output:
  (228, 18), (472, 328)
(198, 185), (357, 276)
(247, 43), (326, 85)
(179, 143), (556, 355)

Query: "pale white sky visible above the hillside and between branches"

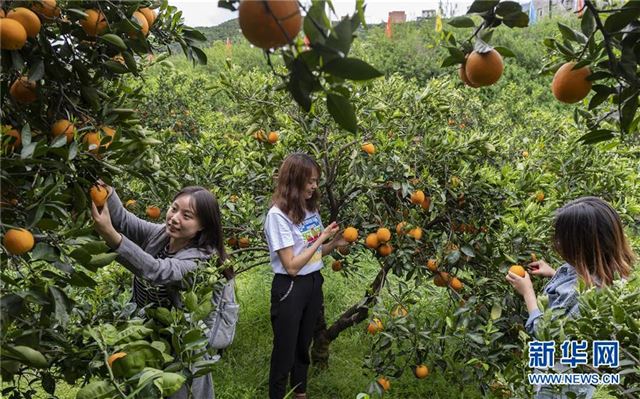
(169, 0), (472, 26)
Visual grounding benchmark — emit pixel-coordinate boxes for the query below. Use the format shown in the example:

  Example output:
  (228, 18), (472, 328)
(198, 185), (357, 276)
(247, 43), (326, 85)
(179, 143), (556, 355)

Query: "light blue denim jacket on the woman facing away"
(525, 263), (579, 336)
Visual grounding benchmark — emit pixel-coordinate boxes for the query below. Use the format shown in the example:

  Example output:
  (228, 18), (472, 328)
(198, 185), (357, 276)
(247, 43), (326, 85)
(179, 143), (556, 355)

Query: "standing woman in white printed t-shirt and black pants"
(264, 153), (347, 399)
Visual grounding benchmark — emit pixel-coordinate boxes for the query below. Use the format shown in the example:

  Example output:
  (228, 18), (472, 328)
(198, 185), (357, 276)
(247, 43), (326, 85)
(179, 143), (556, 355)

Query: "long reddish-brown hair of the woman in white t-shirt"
(272, 152), (321, 224)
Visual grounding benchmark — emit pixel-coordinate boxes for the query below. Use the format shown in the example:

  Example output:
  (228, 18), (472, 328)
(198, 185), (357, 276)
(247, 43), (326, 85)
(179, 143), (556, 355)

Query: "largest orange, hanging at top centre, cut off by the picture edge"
(238, 0), (302, 50)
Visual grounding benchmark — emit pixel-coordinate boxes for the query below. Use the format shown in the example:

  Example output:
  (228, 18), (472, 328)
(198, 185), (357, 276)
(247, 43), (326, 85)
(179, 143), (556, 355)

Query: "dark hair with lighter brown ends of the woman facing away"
(554, 197), (635, 286)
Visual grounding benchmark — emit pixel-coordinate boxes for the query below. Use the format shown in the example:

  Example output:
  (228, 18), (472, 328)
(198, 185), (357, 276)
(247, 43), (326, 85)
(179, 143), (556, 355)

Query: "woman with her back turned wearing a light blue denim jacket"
(506, 197), (635, 399)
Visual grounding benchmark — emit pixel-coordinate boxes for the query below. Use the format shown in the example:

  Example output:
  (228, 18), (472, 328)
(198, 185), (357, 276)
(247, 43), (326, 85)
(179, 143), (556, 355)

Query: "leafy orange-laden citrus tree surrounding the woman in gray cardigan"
(0, 0), (230, 398)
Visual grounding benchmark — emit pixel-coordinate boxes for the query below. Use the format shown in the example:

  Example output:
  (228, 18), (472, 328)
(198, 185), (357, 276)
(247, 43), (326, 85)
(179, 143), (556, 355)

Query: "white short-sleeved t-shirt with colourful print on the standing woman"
(264, 206), (324, 276)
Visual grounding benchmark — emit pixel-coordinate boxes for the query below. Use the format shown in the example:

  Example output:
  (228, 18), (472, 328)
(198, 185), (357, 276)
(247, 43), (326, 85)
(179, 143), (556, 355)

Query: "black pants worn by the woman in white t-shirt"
(269, 272), (324, 399)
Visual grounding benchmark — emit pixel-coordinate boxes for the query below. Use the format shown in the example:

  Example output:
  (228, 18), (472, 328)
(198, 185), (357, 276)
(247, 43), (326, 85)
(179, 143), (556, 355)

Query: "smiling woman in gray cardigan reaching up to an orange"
(92, 186), (229, 398)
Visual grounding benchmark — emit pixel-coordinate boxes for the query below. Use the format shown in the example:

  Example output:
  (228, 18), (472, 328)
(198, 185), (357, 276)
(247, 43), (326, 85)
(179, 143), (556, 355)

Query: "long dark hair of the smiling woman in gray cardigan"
(173, 186), (227, 264)
